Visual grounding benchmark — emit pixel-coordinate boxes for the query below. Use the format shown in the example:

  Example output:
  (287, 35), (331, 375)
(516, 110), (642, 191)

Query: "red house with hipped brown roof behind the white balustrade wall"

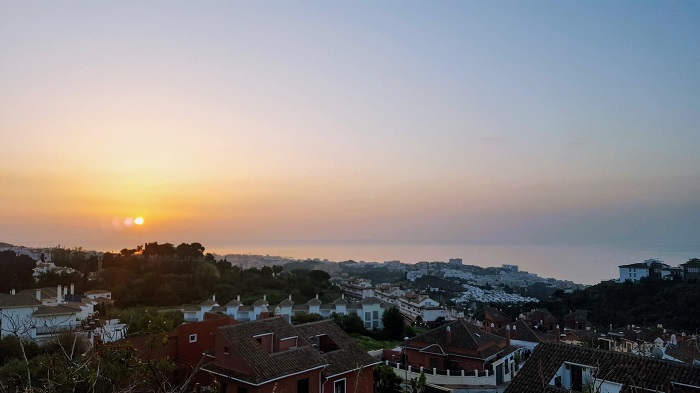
(405, 320), (518, 384)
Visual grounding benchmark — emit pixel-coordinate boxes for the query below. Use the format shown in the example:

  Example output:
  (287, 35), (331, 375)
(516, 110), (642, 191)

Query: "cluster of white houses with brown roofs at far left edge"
(0, 285), (127, 343)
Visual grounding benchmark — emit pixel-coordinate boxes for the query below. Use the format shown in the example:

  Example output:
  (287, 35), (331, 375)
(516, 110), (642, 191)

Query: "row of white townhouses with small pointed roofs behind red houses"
(183, 295), (392, 330)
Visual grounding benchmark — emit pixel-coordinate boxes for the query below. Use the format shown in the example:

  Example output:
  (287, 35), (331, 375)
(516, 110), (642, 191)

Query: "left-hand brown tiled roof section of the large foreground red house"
(204, 318), (327, 385)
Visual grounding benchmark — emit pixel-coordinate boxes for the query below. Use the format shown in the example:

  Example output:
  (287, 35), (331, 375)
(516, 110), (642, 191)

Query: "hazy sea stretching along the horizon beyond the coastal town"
(215, 240), (700, 284)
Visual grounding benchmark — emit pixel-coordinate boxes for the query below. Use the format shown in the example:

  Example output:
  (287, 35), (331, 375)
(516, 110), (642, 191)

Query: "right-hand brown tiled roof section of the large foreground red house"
(294, 320), (377, 377)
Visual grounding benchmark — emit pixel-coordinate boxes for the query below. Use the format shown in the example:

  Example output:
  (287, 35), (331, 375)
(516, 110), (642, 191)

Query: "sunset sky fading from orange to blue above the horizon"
(0, 0), (700, 282)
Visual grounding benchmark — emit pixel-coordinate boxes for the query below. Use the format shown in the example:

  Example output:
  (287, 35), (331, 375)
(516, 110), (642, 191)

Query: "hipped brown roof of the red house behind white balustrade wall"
(408, 320), (506, 359)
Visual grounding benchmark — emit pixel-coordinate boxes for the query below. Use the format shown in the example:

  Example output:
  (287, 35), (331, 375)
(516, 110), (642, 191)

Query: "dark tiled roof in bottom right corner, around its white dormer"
(506, 343), (700, 393)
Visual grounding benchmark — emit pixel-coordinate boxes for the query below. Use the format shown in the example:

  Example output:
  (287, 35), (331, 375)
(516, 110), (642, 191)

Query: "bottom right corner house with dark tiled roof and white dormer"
(505, 343), (700, 393)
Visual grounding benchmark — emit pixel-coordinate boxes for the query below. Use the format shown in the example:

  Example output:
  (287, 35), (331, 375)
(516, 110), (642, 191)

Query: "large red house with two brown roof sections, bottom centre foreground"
(203, 317), (377, 393)
